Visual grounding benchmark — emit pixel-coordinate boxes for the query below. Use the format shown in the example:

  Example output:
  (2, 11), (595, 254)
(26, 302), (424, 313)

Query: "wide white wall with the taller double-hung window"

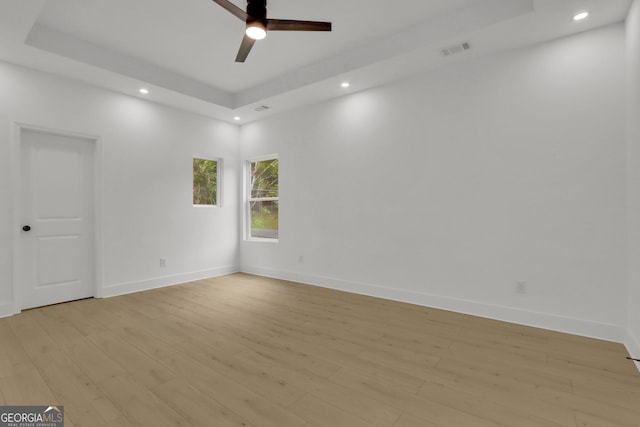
(241, 25), (627, 341)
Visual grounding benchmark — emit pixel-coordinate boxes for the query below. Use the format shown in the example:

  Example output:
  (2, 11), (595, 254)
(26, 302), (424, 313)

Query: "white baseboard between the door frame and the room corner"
(98, 265), (240, 298)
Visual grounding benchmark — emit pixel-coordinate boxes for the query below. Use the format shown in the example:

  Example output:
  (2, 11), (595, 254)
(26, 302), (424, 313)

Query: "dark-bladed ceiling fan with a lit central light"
(213, 0), (331, 62)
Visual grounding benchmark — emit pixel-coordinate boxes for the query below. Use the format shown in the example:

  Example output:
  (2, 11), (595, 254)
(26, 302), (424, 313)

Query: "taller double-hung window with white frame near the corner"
(247, 157), (278, 240)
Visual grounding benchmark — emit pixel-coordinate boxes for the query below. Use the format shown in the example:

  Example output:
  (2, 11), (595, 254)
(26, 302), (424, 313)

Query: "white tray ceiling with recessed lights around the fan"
(0, 0), (630, 123)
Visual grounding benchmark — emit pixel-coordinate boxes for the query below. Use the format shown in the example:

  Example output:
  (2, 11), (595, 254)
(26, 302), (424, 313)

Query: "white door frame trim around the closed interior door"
(11, 122), (103, 314)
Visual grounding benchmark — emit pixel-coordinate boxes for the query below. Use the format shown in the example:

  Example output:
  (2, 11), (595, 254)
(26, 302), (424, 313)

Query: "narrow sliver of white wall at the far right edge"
(626, 0), (640, 368)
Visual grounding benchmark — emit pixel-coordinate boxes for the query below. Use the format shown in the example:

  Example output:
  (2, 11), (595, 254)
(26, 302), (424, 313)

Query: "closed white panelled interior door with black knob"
(18, 129), (95, 309)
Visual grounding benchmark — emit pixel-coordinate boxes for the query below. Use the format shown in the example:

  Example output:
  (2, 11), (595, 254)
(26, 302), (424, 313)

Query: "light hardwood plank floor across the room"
(0, 274), (640, 427)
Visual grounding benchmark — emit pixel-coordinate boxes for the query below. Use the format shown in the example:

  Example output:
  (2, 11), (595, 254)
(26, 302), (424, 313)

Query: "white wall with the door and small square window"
(0, 62), (239, 315)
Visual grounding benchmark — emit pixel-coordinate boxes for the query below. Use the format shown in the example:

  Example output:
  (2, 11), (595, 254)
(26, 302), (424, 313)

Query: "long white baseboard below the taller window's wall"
(241, 266), (627, 343)
